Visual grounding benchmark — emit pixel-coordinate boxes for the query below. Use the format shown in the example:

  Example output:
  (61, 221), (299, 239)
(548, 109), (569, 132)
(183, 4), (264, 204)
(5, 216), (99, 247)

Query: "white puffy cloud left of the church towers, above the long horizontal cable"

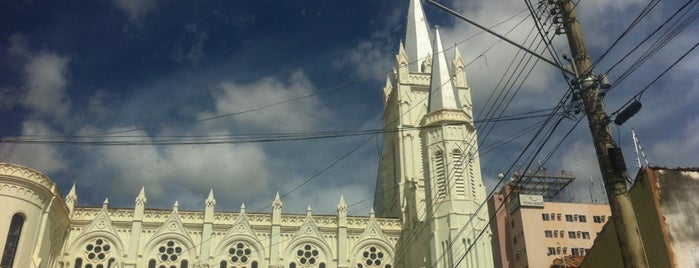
(209, 71), (334, 132)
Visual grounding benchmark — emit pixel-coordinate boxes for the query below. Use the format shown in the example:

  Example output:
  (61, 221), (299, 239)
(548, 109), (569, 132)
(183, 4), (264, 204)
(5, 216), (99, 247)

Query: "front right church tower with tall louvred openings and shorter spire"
(420, 29), (493, 268)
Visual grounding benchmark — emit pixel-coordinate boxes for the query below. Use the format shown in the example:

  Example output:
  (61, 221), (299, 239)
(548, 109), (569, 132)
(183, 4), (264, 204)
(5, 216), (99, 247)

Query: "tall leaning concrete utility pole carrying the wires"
(556, 0), (648, 267)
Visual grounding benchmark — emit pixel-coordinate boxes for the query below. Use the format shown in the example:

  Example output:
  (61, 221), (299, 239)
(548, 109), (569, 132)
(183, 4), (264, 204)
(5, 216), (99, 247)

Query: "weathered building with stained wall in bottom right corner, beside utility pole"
(581, 167), (699, 267)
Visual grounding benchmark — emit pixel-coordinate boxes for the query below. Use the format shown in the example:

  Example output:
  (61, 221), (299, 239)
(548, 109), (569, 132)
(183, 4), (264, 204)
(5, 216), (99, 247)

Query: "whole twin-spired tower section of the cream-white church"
(382, 0), (493, 267)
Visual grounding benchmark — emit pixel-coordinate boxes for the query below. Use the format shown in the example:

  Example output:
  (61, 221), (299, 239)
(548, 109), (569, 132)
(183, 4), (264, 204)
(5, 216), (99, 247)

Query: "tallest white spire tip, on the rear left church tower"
(405, 0), (432, 72)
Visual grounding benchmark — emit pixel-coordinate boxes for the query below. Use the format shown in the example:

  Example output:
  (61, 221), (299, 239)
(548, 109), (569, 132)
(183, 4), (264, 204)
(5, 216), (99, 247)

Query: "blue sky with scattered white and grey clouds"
(0, 0), (699, 215)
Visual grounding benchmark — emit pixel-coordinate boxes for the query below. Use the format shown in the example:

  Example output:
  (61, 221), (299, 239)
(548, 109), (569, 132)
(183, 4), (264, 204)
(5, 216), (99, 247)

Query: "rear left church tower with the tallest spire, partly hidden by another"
(374, 0), (432, 222)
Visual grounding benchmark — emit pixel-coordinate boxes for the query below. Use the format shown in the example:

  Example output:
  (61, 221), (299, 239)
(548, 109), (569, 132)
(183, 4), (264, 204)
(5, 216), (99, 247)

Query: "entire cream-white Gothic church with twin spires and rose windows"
(0, 0), (493, 268)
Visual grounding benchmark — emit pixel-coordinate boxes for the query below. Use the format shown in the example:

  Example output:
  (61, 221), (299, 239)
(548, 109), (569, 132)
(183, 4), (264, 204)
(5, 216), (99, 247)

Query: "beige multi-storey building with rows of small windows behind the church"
(488, 170), (611, 268)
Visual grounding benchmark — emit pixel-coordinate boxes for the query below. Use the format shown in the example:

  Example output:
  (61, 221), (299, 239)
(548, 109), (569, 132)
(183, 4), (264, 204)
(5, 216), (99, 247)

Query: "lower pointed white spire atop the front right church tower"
(428, 28), (460, 112)
